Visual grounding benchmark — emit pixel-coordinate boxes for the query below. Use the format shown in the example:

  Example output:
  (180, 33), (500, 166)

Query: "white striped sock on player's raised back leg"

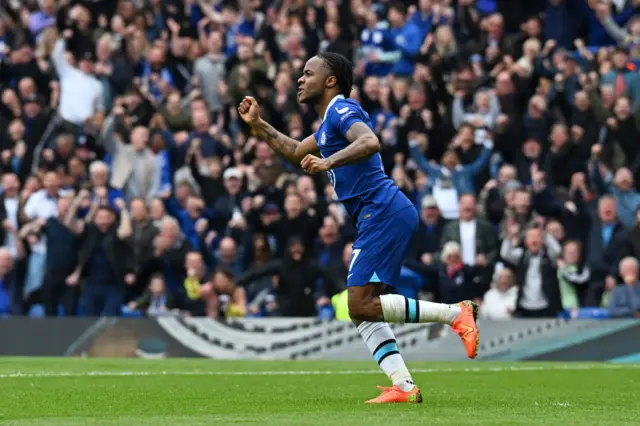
(380, 294), (462, 325)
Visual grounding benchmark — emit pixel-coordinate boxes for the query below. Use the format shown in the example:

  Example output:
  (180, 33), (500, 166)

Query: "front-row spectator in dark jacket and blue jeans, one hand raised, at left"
(66, 199), (135, 316)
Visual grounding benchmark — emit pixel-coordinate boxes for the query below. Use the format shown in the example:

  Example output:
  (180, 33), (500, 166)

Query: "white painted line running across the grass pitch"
(0, 364), (640, 379)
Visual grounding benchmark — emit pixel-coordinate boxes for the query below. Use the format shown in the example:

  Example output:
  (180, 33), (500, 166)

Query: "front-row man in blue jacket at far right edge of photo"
(608, 257), (640, 318)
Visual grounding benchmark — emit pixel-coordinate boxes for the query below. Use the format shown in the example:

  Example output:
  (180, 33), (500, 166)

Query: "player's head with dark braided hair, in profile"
(298, 52), (353, 105)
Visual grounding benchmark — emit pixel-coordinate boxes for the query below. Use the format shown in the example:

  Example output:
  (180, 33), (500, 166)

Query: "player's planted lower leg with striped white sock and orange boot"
(353, 284), (422, 403)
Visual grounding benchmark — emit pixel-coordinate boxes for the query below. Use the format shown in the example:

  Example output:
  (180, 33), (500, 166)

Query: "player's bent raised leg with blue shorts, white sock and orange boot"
(347, 208), (478, 358)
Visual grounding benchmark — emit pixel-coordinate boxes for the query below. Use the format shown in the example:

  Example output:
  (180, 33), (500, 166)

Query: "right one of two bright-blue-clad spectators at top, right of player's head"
(387, 3), (424, 76)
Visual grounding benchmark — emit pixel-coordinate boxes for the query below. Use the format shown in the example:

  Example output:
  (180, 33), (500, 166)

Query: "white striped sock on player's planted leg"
(358, 322), (415, 392)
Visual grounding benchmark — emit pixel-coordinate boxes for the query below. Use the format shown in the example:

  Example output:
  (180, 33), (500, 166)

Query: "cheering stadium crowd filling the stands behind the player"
(0, 0), (640, 319)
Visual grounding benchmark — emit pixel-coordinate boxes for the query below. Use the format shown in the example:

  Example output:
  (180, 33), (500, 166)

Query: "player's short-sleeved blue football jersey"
(314, 96), (412, 222)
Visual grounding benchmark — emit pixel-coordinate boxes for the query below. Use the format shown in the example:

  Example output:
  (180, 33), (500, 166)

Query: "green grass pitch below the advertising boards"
(0, 358), (640, 426)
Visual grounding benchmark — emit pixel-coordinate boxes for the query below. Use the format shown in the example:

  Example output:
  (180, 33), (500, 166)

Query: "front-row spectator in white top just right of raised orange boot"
(480, 267), (518, 320)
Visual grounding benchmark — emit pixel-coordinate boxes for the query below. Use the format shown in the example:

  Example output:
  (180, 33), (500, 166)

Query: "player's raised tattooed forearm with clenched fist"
(238, 96), (318, 165)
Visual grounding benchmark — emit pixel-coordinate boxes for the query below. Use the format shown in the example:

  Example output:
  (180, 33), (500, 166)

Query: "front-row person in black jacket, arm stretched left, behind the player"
(237, 237), (333, 317)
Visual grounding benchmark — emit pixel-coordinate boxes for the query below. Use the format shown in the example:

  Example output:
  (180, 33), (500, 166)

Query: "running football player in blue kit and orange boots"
(238, 53), (478, 404)
